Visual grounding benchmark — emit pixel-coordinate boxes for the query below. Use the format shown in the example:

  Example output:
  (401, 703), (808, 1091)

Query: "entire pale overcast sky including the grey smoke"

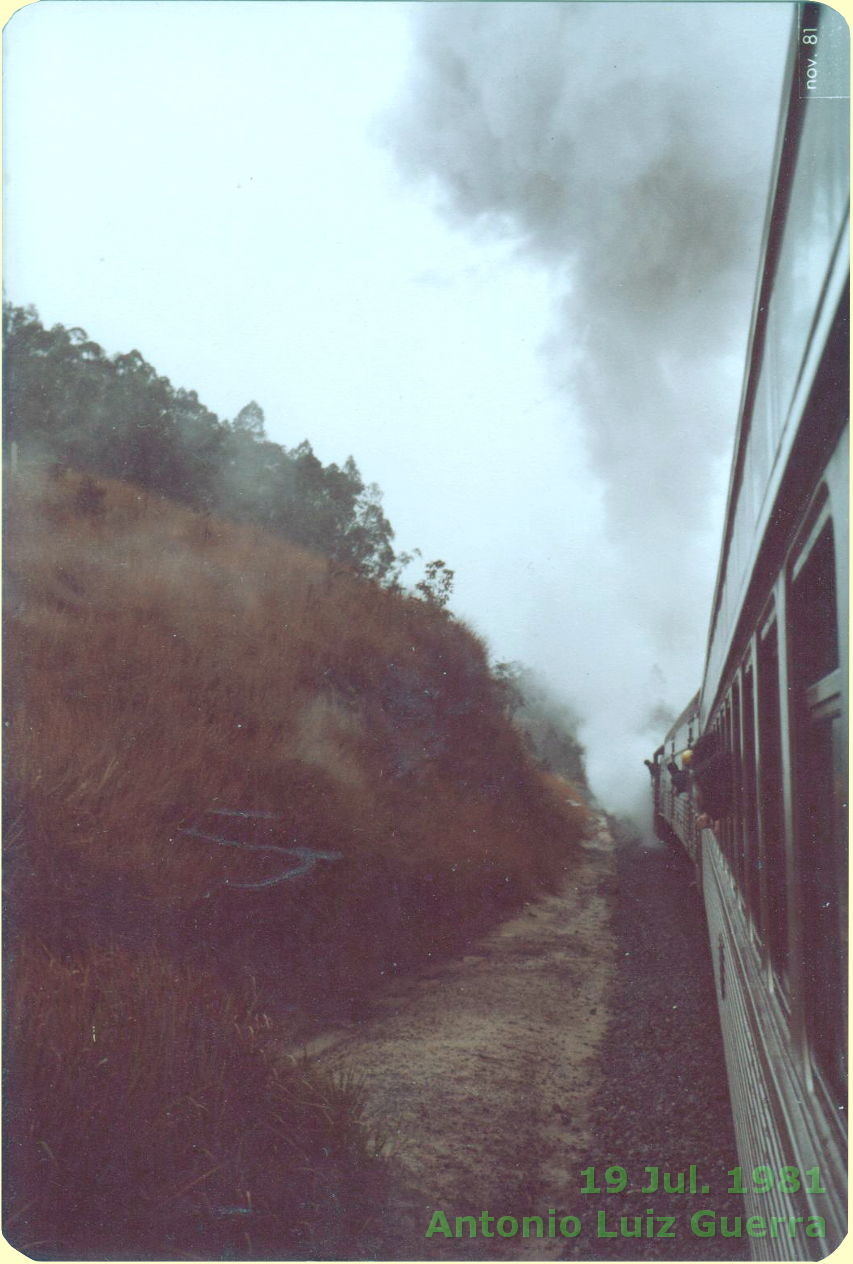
(4, 0), (792, 810)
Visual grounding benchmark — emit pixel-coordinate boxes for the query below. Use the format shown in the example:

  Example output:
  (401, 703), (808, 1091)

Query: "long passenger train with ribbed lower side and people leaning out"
(647, 5), (849, 1259)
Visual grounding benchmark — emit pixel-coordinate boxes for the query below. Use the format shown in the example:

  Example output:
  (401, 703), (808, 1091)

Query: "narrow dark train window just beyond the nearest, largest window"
(757, 622), (789, 988)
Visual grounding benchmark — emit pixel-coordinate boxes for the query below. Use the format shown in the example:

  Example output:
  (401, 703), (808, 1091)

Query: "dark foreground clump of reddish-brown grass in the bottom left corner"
(4, 939), (383, 1259)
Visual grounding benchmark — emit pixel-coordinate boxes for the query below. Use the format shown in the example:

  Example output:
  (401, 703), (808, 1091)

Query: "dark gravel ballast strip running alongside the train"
(565, 827), (749, 1260)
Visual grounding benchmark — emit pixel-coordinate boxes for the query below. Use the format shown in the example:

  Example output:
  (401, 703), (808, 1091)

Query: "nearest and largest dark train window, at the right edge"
(789, 520), (848, 1093)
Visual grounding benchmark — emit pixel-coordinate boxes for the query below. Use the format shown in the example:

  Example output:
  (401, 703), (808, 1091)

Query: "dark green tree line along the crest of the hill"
(3, 303), (452, 591)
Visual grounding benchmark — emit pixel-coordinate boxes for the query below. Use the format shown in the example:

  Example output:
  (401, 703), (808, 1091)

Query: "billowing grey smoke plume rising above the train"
(385, 3), (790, 819)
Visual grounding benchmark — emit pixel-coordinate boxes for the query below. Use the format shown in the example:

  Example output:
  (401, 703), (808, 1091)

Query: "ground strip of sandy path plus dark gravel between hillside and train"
(290, 818), (746, 1260)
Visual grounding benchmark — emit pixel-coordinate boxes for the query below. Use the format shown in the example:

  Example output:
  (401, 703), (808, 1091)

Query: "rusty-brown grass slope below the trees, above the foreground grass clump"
(5, 465), (583, 956)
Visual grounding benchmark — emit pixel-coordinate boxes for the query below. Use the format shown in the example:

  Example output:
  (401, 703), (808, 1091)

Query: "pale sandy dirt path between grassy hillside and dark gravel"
(310, 818), (615, 1259)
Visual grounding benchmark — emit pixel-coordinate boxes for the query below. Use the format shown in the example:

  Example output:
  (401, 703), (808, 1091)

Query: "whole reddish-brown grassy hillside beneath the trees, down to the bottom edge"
(5, 471), (583, 1258)
